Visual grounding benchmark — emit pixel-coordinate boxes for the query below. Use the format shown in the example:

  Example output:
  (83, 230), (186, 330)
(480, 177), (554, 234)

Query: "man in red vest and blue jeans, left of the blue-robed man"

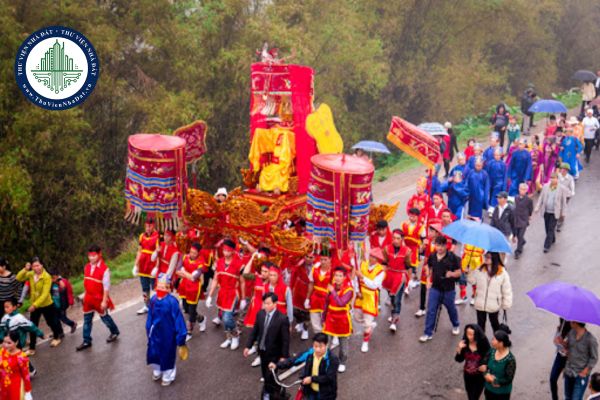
(77, 245), (120, 351)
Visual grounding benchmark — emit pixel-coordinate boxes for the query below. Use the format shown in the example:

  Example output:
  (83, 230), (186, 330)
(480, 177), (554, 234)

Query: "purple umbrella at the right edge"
(527, 282), (600, 325)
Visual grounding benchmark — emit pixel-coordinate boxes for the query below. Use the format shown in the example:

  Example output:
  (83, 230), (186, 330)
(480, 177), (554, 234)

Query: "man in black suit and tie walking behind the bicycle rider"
(244, 292), (290, 400)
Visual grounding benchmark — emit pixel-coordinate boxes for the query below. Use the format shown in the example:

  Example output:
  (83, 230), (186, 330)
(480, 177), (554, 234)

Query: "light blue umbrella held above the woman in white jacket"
(442, 219), (512, 253)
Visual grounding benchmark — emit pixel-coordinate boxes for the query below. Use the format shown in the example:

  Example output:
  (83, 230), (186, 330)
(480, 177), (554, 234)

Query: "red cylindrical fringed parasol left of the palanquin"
(125, 133), (187, 229)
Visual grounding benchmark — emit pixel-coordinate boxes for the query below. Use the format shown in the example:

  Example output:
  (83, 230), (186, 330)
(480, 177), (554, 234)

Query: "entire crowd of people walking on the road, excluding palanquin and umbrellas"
(0, 100), (600, 399)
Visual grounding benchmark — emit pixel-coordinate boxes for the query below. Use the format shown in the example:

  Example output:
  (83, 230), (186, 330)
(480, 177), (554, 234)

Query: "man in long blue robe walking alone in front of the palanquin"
(146, 274), (187, 386)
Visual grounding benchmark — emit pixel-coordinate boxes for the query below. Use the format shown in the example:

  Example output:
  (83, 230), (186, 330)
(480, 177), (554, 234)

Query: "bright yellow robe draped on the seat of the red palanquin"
(248, 125), (296, 193)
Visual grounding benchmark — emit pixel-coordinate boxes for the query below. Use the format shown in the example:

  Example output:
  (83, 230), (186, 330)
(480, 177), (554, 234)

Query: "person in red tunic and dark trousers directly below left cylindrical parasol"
(133, 218), (160, 315)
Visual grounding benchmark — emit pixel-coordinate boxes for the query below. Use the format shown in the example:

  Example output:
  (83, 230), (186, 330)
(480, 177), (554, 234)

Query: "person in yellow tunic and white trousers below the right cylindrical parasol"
(354, 248), (385, 353)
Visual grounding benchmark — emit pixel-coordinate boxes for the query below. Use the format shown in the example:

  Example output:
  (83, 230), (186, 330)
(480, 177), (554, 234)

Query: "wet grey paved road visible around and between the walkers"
(33, 152), (600, 400)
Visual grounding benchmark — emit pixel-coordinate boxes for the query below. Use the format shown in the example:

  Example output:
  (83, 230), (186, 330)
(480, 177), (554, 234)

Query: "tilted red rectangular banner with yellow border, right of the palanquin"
(387, 117), (441, 168)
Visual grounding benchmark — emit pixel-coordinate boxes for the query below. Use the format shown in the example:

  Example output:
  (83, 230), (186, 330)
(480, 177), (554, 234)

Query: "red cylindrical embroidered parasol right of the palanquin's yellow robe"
(306, 154), (374, 250)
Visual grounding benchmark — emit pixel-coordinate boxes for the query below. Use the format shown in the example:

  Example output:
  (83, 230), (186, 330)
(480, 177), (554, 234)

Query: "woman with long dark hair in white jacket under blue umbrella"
(468, 253), (513, 332)
